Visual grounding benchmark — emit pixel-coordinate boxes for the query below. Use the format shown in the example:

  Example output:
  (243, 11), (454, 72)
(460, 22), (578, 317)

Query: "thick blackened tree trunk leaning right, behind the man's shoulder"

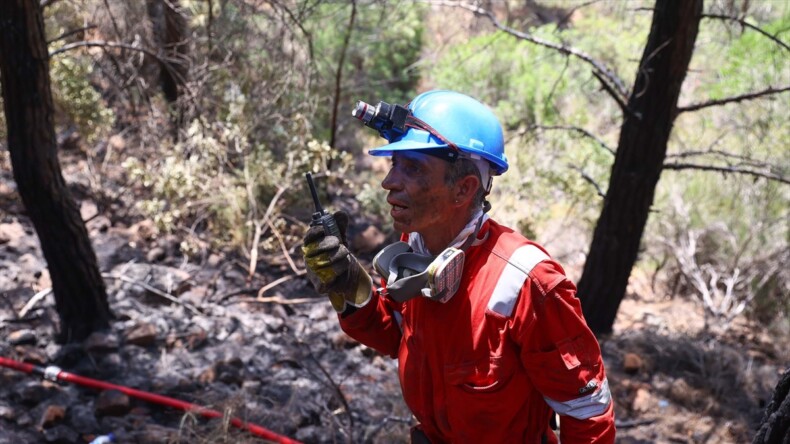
(578, 0), (703, 333)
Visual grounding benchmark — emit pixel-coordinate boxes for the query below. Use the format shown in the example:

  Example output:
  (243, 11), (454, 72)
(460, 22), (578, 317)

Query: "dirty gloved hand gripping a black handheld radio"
(302, 211), (373, 315)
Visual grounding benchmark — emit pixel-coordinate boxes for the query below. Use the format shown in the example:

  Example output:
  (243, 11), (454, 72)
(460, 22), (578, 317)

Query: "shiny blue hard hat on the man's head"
(368, 90), (508, 175)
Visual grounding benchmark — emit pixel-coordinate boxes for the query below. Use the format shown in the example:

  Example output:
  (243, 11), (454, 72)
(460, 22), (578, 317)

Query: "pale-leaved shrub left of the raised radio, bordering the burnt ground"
(123, 121), (350, 256)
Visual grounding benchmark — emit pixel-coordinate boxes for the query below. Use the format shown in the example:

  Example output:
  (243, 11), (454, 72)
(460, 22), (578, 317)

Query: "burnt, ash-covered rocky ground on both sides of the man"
(0, 147), (788, 443)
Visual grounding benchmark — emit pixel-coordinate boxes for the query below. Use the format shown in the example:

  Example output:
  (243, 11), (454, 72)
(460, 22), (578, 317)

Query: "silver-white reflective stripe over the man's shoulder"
(488, 245), (549, 317)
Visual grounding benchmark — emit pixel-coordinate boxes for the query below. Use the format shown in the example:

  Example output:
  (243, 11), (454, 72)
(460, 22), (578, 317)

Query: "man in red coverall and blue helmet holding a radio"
(303, 91), (615, 443)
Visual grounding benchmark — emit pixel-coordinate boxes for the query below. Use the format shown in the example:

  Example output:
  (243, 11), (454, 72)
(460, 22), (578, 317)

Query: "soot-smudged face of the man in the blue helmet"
(381, 151), (459, 240)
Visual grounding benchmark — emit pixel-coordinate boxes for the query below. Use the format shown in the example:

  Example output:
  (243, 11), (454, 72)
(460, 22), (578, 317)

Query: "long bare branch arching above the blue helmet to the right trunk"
(427, 0), (628, 103)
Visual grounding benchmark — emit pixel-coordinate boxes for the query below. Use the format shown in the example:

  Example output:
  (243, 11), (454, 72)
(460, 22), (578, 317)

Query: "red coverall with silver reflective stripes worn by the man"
(340, 219), (615, 444)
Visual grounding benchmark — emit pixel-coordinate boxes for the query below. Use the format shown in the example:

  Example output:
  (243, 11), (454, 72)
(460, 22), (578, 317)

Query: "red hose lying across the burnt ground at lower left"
(0, 356), (301, 444)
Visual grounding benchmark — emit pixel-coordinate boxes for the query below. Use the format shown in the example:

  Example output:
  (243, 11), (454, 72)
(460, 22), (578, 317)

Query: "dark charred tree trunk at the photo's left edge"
(0, 0), (112, 343)
